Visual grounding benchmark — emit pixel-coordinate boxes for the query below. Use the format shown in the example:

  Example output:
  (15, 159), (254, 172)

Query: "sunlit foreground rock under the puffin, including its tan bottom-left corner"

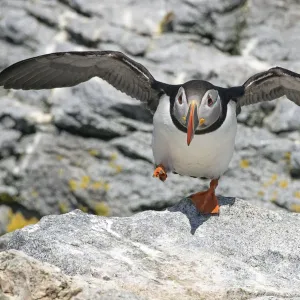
(0, 198), (300, 299)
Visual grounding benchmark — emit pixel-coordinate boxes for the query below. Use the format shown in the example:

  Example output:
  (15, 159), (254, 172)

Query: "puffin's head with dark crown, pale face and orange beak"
(172, 80), (222, 145)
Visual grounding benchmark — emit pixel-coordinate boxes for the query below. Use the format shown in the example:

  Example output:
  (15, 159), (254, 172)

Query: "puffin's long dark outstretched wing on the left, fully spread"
(0, 51), (163, 112)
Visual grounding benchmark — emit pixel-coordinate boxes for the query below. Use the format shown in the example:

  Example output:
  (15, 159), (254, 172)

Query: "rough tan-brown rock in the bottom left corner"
(0, 251), (80, 300)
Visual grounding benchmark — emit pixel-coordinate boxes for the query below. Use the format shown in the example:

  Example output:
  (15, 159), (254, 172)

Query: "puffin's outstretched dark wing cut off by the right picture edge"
(237, 67), (300, 106)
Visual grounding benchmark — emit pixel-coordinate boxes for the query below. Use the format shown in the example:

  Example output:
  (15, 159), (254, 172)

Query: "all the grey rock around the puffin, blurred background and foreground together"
(0, 0), (300, 300)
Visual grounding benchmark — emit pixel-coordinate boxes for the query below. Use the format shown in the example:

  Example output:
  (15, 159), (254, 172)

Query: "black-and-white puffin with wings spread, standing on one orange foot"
(0, 51), (300, 214)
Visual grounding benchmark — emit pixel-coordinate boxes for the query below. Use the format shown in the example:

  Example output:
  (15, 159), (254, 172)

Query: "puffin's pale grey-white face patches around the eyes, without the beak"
(173, 87), (222, 131)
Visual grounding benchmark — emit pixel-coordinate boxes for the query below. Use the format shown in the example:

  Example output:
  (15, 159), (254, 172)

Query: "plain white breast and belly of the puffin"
(152, 97), (237, 178)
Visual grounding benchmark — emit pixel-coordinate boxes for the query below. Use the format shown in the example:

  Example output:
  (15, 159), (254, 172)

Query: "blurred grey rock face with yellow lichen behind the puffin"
(0, 0), (300, 234)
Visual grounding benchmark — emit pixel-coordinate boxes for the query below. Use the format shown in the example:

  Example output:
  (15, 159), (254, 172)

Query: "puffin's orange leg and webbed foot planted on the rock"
(189, 179), (219, 214)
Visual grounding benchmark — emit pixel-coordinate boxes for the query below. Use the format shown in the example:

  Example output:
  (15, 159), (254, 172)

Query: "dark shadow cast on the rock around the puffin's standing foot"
(167, 196), (235, 235)
